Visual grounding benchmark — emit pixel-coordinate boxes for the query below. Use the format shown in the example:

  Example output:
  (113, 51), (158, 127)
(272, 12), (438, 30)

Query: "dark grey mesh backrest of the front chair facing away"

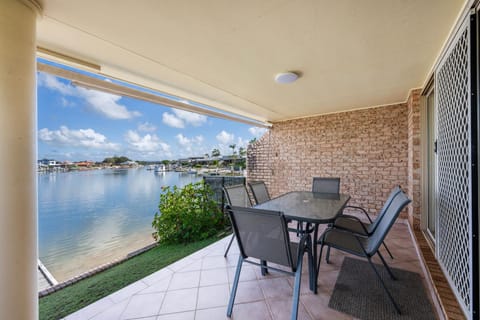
(227, 207), (295, 271)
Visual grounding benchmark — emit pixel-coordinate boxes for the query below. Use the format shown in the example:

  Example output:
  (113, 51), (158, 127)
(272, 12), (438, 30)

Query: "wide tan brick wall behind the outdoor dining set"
(247, 103), (409, 218)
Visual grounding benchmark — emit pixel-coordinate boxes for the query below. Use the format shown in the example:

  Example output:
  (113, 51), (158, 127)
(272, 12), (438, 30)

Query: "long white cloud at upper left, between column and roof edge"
(38, 73), (141, 120)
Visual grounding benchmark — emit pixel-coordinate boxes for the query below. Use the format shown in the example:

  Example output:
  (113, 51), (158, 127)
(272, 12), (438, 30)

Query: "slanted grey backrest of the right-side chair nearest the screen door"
(365, 191), (411, 255)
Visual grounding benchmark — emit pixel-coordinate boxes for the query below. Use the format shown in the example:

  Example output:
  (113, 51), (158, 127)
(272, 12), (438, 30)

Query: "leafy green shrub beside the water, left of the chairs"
(152, 181), (226, 243)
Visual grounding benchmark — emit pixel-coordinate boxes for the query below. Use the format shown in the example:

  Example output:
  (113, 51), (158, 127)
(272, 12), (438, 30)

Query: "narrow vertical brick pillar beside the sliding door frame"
(407, 89), (421, 226)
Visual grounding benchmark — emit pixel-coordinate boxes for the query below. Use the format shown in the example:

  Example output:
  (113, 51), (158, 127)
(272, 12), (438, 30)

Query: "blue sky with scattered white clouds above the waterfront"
(37, 61), (265, 161)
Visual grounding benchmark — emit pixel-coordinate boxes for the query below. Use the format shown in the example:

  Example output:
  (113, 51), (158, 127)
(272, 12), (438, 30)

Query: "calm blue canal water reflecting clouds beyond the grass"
(38, 168), (201, 281)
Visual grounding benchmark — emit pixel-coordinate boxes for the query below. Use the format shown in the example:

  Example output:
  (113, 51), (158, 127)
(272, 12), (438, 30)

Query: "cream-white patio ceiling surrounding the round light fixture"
(38, 0), (467, 122)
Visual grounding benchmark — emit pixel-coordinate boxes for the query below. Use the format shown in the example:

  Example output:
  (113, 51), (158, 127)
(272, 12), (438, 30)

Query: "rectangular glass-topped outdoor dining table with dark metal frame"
(255, 191), (350, 293)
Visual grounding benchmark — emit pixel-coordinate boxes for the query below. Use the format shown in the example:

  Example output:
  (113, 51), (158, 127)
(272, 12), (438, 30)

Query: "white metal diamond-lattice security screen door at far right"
(435, 21), (472, 315)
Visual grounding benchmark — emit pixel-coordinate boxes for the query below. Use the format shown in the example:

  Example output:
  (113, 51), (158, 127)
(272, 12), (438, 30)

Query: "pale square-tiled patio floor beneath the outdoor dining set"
(65, 223), (432, 320)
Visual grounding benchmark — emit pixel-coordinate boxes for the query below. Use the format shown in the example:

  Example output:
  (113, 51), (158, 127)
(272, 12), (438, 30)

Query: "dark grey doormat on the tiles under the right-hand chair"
(328, 257), (436, 320)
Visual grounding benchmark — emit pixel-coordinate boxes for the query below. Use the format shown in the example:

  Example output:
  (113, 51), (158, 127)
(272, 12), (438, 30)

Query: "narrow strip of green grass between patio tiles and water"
(39, 237), (220, 320)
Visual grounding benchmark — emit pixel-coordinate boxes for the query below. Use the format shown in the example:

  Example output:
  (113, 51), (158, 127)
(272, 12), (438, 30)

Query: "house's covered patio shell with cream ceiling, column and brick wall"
(0, 0), (480, 319)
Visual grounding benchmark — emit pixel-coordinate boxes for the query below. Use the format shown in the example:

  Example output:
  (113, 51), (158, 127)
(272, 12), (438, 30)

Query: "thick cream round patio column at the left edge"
(0, 0), (39, 320)
